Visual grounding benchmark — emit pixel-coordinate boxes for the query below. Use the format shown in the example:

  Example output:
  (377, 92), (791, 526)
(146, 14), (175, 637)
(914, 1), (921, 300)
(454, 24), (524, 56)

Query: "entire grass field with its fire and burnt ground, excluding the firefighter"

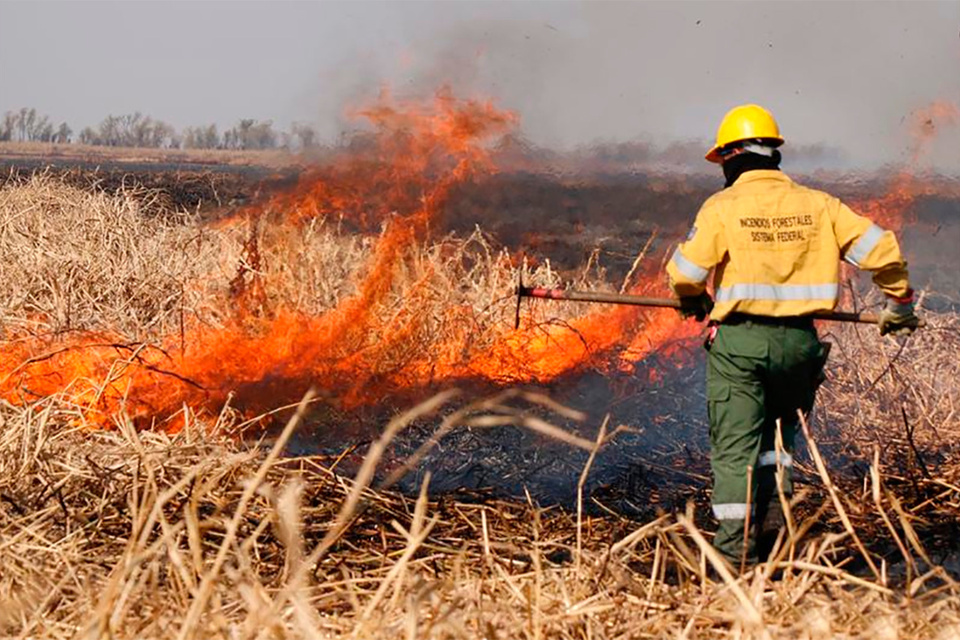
(0, 96), (960, 639)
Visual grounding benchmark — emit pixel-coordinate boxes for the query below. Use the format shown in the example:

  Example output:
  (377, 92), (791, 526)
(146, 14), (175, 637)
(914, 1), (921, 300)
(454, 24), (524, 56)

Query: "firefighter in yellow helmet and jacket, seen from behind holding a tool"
(667, 104), (919, 567)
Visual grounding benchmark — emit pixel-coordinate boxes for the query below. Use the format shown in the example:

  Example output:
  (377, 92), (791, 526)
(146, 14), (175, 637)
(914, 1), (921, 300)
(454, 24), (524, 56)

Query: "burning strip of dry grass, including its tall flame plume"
(0, 94), (690, 430)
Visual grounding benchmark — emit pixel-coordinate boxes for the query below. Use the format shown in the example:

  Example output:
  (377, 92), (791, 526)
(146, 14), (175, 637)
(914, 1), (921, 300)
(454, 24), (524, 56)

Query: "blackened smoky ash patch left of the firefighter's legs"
(289, 350), (710, 518)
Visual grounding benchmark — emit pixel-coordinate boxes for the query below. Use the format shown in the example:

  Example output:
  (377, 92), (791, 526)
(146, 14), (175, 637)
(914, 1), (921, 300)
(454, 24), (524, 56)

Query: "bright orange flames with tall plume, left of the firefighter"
(0, 91), (690, 430)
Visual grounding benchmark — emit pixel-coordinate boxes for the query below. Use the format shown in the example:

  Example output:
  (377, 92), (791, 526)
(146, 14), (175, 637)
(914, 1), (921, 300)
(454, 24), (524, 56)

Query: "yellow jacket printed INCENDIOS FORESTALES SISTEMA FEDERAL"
(667, 170), (910, 320)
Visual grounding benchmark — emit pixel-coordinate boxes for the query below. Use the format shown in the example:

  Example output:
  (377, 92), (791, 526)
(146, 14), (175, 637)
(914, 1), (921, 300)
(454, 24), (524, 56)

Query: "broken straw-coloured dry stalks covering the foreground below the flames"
(0, 370), (960, 638)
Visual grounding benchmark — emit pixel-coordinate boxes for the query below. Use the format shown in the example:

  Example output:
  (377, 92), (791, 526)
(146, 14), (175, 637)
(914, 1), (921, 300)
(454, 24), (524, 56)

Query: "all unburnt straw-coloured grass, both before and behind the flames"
(0, 172), (960, 639)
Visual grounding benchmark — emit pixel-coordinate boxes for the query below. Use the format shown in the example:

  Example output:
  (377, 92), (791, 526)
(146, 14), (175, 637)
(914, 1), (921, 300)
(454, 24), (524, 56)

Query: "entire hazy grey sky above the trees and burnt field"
(0, 0), (960, 169)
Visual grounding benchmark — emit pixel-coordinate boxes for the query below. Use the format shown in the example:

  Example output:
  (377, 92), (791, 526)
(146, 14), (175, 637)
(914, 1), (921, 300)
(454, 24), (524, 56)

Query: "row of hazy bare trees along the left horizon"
(0, 107), (319, 150)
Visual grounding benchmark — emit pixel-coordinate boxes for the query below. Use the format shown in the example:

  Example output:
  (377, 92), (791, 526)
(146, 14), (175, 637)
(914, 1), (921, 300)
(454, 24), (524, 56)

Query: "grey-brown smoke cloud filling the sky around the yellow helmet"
(368, 2), (960, 172)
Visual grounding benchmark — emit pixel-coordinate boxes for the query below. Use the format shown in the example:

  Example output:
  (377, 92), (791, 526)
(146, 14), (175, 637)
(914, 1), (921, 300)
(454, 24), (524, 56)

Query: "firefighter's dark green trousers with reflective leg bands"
(707, 320), (827, 566)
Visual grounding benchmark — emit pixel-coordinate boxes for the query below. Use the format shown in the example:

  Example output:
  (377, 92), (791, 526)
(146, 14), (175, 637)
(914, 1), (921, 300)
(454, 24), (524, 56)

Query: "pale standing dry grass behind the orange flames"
(0, 175), (576, 341)
